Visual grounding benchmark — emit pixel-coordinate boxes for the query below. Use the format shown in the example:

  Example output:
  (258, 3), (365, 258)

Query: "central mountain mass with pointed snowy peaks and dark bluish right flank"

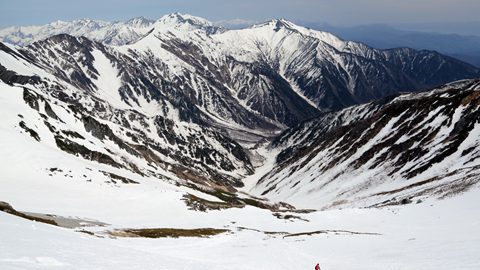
(126, 14), (479, 121)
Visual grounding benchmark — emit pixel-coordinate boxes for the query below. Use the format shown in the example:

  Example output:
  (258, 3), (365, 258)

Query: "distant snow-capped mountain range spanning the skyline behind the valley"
(0, 13), (478, 116)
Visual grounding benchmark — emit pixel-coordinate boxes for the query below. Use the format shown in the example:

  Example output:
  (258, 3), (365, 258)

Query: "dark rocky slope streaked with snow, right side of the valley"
(253, 80), (480, 208)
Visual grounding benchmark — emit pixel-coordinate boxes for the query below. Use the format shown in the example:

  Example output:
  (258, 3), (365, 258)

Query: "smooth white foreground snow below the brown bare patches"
(0, 187), (480, 270)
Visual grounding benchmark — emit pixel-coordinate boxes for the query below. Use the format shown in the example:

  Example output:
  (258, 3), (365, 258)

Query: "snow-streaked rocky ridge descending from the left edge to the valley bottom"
(0, 41), (253, 189)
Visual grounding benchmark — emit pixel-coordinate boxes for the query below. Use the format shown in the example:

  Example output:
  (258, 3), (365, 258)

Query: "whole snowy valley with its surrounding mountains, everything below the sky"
(0, 13), (480, 270)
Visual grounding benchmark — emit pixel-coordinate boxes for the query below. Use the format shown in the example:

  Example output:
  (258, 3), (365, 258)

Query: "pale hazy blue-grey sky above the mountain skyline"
(0, 0), (480, 33)
